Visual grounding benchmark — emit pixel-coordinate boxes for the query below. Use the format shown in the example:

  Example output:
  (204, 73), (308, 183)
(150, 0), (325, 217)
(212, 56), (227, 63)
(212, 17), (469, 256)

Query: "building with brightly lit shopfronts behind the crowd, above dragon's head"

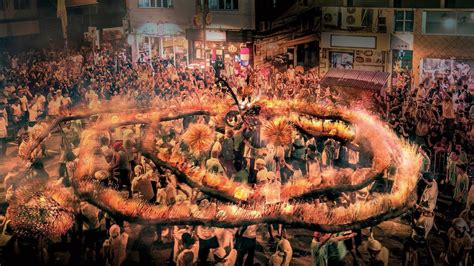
(126, 0), (255, 64)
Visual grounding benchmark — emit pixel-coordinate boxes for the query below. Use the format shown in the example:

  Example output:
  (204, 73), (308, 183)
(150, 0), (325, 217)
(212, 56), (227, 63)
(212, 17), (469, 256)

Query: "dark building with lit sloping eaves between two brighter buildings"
(254, 1), (321, 68)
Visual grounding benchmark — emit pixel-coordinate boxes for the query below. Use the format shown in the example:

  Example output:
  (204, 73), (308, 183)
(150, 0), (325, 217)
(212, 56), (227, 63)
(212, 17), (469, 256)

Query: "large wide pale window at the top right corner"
(422, 11), (474, 36)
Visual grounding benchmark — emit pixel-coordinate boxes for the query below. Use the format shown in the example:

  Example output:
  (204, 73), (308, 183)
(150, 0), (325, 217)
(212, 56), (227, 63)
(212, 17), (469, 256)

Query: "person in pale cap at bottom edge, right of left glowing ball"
(104, 224), (128, 266)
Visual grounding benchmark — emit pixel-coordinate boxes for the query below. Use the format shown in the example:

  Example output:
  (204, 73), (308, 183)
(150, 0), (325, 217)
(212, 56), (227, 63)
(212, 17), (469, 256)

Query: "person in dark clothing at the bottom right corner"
(442, 218), (472, 265)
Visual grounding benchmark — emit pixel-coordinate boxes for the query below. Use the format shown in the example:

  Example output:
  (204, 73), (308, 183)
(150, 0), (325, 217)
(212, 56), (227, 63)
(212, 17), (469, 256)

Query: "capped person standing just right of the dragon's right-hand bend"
(415, 172), (438, 238)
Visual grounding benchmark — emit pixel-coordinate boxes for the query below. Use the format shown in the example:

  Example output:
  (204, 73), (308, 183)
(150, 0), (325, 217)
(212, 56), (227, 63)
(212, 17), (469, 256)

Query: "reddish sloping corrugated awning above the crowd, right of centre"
(321, 68), (390, 90)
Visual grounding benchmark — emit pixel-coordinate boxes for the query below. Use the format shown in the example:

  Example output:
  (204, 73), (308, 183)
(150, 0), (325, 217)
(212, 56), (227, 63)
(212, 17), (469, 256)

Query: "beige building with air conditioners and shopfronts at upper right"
(316, 0), (474, 89)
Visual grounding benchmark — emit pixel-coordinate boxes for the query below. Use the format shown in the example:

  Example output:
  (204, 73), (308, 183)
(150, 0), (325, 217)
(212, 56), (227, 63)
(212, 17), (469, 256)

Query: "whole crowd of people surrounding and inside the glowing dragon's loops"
(0, 42), (474, 265)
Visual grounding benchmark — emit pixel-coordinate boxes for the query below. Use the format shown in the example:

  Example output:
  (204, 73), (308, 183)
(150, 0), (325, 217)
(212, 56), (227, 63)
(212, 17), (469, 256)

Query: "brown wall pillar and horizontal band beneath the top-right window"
(413, 9), (474, 84)
